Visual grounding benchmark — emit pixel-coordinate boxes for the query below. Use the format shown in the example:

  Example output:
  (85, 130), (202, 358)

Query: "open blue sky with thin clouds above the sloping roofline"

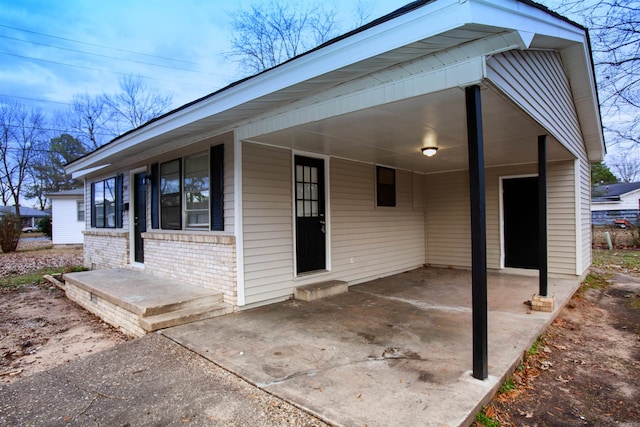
(0, 0), (407, 114)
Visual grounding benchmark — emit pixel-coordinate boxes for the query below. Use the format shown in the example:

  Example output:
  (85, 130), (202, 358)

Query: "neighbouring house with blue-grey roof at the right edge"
(591, 182), (640, 225)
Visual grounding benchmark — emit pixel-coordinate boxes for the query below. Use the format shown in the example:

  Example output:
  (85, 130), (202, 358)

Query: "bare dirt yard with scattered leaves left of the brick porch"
(0, 242), (127, 383)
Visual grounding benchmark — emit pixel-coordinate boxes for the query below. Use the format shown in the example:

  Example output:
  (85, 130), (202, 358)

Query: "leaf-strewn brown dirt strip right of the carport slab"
(477, 270), (640, 427)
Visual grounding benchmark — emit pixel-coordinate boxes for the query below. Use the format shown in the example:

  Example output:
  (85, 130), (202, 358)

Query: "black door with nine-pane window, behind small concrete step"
(294, 156), (326, 273)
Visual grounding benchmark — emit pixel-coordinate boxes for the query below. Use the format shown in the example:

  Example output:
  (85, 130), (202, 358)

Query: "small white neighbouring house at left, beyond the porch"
(47, 188), (85, 245)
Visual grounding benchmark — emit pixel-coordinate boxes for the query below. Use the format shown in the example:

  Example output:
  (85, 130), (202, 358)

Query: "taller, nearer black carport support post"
(465, 85), (489, 380)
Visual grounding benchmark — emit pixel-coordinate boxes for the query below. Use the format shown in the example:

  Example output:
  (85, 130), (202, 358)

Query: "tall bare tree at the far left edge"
(0, 100), (45, 216)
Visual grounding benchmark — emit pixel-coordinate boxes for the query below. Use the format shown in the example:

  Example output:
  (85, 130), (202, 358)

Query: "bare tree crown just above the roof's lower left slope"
(103, 76), (173, 134)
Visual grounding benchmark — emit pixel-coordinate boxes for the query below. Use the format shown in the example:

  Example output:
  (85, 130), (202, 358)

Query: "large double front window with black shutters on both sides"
(151, 144), (224, 231)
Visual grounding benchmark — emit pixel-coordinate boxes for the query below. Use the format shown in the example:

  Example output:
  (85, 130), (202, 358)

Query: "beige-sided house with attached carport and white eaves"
(66, 0), (604, 309)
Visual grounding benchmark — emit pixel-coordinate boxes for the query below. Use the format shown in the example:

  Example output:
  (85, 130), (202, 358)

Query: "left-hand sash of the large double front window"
(160, 159), (182, 230)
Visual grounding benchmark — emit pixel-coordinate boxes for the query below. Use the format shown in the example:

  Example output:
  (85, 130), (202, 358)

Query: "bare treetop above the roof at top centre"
(228, 0), (337, 74)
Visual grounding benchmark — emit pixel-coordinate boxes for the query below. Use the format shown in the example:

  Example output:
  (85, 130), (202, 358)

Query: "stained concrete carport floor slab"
(163, 268), (579, 427)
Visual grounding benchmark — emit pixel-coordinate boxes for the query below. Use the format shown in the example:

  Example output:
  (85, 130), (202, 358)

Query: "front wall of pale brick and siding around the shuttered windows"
(83, 134), (237, 305)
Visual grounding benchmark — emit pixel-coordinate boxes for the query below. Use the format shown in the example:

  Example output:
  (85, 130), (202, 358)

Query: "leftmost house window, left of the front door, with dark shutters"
(91, 175), (122, 228)
